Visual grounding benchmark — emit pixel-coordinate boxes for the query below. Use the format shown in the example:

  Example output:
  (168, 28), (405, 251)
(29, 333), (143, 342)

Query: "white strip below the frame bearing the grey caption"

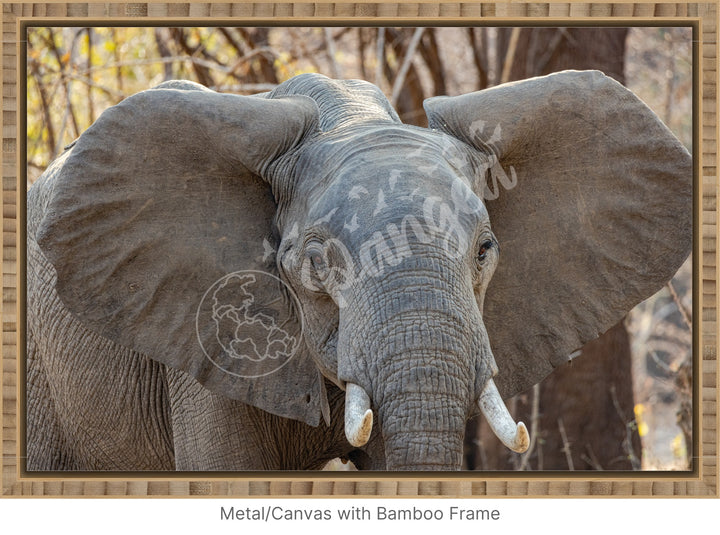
(0, 498), (720, 535)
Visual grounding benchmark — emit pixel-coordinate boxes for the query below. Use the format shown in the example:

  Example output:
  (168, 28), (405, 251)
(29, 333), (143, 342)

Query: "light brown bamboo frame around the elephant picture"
(0, 0), (718, 497)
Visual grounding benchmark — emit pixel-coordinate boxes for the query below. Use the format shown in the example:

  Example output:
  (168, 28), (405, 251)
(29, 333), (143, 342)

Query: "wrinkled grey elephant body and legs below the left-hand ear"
(27, 184), (366, 471)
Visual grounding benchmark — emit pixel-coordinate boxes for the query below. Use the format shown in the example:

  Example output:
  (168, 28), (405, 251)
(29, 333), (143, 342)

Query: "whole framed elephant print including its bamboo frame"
(0, 3), (716, 506)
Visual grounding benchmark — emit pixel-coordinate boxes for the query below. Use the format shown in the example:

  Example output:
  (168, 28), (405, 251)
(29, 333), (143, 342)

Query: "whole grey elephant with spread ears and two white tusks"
(26, 71), (693, 471)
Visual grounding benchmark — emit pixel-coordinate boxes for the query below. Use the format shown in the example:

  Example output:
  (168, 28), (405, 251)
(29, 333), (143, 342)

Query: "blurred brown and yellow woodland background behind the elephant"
(27, 27), (693, 470)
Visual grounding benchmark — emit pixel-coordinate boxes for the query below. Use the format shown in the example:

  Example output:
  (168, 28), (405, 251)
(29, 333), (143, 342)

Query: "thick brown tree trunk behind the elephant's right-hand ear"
(466, 28), (640, 470)
